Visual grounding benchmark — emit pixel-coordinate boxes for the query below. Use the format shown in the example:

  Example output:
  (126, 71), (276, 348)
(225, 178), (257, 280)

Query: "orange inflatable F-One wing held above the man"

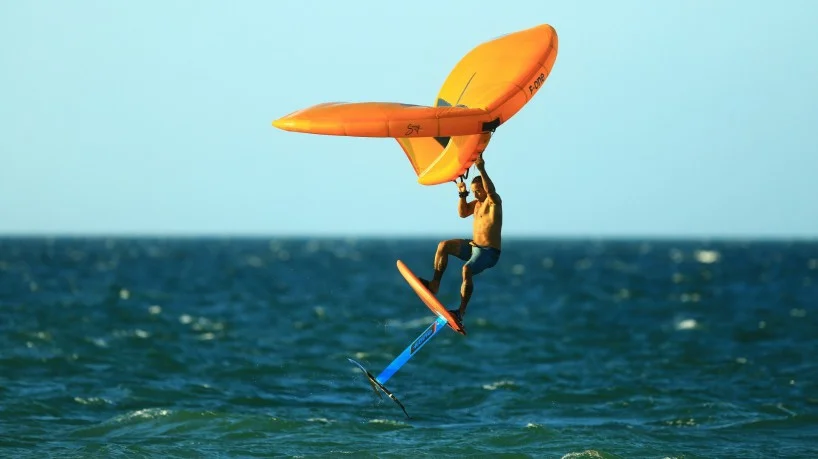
(273, 24), (557, 185)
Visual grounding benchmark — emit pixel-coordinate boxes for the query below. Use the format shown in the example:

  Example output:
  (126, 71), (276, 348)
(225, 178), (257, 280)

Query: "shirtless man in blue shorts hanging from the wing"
(421, 154), (503, 321)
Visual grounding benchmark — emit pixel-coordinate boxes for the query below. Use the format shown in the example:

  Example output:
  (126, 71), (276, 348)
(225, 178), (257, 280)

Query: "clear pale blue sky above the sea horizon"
(0, 0), (818, 238)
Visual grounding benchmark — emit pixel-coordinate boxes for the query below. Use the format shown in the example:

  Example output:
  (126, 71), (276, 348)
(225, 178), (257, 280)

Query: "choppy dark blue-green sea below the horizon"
(0, 238), (818, 459)
